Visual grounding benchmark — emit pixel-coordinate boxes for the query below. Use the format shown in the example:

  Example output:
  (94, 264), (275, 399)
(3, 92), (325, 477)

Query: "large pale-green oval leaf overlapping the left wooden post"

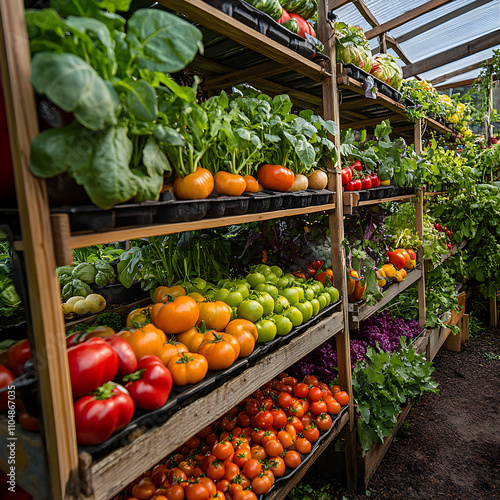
(31, 52), (118, 130)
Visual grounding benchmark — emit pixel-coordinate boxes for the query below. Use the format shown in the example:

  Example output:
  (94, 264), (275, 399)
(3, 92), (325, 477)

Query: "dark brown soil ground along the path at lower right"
(294, 322), (500, 500)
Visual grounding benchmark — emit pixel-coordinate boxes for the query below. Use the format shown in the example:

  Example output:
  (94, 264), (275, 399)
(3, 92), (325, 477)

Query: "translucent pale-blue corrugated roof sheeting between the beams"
(334, 0), (500, 83)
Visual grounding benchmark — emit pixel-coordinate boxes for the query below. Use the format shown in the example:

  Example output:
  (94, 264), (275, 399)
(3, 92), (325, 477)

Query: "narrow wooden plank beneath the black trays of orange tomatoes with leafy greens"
(68, 203), (335, 248)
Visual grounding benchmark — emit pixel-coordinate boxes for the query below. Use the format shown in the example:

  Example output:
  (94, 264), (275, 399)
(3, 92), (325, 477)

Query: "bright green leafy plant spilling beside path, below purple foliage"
(352, 337), (438, 456)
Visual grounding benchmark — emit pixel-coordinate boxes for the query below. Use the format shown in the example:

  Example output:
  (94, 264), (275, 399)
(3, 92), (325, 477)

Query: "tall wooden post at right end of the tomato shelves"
(318, 0), (357, 490)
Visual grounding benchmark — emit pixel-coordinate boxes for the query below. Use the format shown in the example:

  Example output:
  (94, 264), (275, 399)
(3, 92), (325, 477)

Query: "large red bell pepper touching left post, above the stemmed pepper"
(68, 337), (118, 398)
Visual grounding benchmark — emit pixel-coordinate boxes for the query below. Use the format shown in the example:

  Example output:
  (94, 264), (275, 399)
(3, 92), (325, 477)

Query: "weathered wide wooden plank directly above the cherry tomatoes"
(85, 312), (343, 500)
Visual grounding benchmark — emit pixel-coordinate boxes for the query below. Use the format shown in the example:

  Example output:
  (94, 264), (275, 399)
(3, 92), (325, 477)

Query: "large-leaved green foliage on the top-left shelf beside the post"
(26, 0), (201, 209)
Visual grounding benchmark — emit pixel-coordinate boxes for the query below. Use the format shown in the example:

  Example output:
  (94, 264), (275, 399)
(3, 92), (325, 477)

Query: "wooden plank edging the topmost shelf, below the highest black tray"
(159, 0), (331, 81)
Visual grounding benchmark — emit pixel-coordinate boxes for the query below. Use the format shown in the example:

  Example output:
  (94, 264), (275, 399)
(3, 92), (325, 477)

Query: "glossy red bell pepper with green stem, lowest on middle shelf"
(75, 384), (135, 445)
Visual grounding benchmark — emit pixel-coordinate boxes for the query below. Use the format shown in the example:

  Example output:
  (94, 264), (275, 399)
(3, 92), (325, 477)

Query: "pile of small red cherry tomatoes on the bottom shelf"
(115, 373), (349, 500)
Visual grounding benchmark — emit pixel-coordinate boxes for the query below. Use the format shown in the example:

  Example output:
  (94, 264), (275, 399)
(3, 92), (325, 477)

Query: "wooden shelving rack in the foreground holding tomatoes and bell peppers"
(0, 0), (355, 500)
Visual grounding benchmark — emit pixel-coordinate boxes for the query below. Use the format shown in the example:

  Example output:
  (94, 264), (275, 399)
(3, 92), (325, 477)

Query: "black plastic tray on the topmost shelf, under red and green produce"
(205, 0), (316, 59)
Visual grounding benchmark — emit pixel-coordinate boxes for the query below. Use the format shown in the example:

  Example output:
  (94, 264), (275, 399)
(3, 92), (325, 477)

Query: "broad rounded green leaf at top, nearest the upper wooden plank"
(127, 9), (202, 73)
